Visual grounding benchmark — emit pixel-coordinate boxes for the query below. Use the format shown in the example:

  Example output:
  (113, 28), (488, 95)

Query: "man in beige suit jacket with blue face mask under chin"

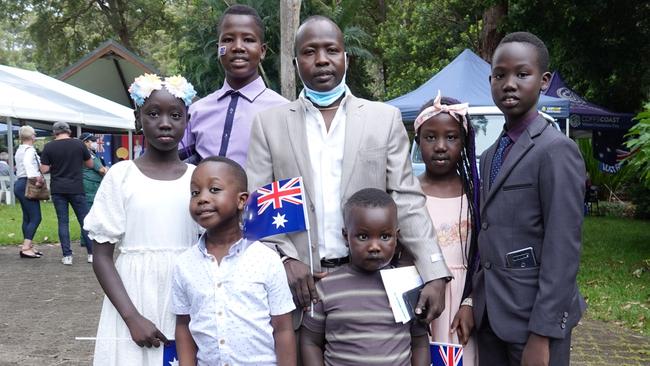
(246, 16), (451, 322)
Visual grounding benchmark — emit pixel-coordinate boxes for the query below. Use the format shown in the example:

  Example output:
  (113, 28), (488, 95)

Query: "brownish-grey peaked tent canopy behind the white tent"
(58, 40), (158, 108)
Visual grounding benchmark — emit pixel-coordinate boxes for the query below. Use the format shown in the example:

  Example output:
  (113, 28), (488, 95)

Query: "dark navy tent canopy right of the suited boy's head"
(544, 71), (634, 131)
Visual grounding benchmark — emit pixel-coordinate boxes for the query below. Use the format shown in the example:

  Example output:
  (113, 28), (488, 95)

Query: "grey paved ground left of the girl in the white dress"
(0, 244), (103, 366)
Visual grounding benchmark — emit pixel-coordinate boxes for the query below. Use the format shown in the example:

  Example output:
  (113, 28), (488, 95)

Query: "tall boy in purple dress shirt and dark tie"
(179, 5), (288, 167)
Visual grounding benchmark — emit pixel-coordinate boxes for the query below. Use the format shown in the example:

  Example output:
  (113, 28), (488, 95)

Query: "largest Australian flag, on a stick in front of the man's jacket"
(243, 177), (307, 240)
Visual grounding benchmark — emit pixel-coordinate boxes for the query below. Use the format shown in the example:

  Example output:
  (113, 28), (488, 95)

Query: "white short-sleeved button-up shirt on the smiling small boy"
(172, 235), (295, 366)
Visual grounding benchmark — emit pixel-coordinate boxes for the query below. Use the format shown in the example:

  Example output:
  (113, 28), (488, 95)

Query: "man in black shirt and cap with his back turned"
(41, 122), (93, 265)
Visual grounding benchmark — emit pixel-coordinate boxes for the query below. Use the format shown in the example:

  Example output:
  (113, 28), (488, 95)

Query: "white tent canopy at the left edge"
(0, 65), (135, 130)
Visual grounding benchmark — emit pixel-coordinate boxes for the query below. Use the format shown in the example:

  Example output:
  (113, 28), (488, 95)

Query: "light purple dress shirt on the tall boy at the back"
(178, 77), (288, 168)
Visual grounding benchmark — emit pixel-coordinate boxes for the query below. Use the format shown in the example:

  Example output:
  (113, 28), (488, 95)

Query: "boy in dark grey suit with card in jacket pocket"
(472, 32), (585, 365)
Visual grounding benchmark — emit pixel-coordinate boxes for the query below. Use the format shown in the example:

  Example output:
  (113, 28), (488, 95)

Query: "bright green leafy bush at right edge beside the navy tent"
(626, 103), (650, 187)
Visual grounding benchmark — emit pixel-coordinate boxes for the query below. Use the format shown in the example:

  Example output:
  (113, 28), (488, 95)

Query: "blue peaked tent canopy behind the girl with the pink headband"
(386, 49), (569, 121)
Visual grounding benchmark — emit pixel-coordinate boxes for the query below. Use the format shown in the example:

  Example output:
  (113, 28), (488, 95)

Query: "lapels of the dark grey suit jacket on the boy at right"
(483, 117), (548, 207)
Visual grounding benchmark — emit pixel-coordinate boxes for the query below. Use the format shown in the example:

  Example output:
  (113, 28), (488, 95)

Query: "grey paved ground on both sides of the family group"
(0, 244), (650, 366)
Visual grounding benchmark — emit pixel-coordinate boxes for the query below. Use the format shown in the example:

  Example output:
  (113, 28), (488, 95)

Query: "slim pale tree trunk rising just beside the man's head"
(280, 0), (301, 100)
